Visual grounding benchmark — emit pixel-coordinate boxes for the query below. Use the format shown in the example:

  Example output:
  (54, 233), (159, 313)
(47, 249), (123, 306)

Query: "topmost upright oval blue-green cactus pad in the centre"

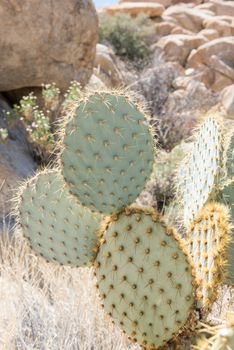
(61, 93), (154, 214)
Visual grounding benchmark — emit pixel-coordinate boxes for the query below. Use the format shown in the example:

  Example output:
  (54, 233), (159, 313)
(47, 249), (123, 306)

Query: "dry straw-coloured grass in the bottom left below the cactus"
(0, 231), (139, 350)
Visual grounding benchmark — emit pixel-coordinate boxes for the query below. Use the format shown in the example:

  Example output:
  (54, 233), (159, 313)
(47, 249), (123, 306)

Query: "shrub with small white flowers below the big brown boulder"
(4, 81), (81, 164)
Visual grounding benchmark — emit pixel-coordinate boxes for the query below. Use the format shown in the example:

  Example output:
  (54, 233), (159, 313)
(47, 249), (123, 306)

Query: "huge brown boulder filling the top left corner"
(0, 0), (98, 91)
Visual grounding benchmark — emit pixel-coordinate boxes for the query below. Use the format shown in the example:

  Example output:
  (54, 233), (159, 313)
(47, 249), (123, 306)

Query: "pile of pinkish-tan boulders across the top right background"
(102, 0), (234, 92)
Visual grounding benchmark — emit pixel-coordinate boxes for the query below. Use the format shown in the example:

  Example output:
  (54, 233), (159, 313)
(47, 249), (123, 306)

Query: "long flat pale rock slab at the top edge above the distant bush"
(102, 1), (164, 17)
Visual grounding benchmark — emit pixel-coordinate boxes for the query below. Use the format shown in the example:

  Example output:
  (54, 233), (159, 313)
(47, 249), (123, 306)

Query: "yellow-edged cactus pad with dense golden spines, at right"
(187, 203), (232, 310)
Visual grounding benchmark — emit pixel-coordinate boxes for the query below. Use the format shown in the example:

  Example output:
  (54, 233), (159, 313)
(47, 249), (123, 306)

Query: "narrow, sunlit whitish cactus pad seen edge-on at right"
(178, 116), (223, 228)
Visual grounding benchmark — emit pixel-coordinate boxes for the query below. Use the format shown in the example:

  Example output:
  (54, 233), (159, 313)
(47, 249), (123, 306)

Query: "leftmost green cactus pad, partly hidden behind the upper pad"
(17, 170), (102, 267)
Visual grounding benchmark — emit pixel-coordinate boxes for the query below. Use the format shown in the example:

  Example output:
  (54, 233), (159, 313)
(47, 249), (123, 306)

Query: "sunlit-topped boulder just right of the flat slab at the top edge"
(162, 4), (214, 33)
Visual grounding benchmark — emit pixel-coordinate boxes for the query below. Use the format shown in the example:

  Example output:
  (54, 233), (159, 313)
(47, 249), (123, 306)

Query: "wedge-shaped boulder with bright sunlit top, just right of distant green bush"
(155, 34), (207, 65)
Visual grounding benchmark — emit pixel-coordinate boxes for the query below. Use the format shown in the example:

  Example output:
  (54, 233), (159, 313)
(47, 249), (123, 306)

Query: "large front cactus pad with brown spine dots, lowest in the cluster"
(95, 208), (196, 349)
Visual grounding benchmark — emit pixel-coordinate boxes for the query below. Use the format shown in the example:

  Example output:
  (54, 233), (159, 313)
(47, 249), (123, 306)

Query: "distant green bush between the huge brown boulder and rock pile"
(99, 14), (154, 64)
